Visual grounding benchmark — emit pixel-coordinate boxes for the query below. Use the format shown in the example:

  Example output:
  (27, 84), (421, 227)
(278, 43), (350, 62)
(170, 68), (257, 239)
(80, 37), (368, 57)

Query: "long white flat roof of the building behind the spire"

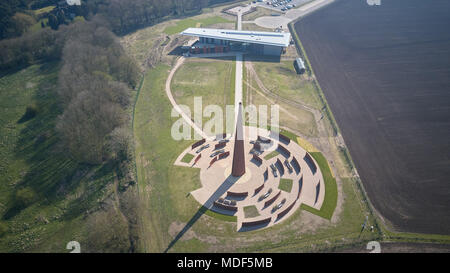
(181, 28), (291, 47)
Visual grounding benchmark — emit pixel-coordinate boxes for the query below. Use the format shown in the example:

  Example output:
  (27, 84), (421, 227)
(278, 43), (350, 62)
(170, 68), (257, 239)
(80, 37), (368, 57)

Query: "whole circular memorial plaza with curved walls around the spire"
(175, 126), (325, 231)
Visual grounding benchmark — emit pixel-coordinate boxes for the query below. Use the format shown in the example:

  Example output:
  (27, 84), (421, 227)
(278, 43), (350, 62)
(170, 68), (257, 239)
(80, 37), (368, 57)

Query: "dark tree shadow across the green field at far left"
(1, 63), (110, 220)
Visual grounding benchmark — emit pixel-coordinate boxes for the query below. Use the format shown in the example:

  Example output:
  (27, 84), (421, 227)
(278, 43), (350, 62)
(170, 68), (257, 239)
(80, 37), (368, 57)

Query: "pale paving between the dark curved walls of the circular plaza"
(175, 127), (325, 231)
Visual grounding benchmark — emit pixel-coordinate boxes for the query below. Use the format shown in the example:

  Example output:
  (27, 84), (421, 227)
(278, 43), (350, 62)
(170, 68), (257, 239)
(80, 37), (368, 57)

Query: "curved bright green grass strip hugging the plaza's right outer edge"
(302, 152), (337, 219)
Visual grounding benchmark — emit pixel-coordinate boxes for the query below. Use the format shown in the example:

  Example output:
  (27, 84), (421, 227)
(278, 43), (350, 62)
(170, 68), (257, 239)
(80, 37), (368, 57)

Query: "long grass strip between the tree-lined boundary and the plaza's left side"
(134, 65), (205, 252)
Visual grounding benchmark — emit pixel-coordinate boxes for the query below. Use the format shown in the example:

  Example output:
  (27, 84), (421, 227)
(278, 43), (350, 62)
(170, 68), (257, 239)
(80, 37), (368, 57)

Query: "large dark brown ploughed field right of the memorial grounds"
(295, 0), (450, 234)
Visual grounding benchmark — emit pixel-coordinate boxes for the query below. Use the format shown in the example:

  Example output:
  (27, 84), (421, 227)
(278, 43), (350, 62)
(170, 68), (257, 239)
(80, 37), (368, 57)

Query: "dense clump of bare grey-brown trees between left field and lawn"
(56, 20), (139, 164)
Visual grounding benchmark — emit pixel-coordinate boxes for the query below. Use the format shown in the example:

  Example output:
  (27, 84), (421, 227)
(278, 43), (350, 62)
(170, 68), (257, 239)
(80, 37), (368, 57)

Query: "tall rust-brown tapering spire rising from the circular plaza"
(231, 102), (245, 177)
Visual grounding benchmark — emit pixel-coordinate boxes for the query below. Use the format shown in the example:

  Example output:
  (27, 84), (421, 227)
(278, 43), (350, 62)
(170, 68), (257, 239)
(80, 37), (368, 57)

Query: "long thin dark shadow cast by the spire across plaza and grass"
(164, 175), (238, 253)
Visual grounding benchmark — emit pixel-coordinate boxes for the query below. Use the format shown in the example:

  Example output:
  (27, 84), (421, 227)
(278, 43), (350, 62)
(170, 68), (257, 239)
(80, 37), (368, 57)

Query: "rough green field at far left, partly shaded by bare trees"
(0, 63), (129, 252)
